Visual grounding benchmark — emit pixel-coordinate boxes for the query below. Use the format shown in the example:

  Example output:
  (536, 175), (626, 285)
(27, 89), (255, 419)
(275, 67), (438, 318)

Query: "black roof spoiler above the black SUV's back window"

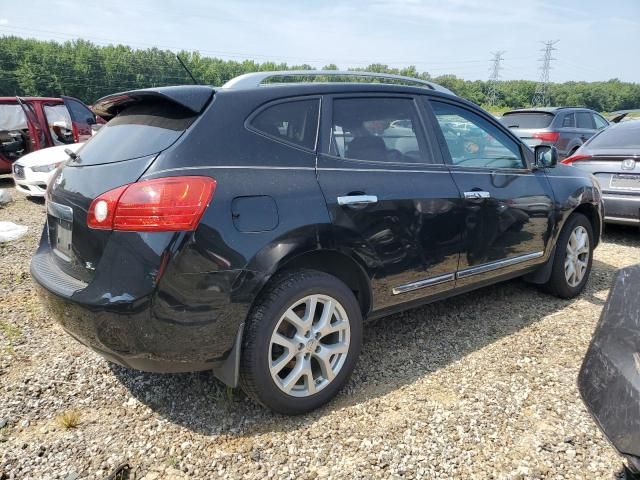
(93, 85), (215, 120)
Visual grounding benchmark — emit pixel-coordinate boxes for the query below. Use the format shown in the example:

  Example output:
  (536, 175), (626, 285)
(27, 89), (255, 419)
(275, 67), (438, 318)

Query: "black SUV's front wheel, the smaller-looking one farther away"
(542, 213), (593, 298)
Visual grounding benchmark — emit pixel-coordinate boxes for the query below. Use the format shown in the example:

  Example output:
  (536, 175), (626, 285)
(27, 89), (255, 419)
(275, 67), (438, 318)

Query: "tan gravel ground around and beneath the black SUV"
(0, 178), (640, 480)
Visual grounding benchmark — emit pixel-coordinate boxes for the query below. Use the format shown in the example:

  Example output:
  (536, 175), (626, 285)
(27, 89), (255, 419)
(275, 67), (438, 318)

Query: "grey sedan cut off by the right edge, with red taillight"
(562, 120), (640, 225)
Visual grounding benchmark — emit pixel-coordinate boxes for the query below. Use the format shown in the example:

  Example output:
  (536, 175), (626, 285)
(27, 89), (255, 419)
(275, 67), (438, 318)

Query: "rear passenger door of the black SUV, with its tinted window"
(317, 94), (463, 310)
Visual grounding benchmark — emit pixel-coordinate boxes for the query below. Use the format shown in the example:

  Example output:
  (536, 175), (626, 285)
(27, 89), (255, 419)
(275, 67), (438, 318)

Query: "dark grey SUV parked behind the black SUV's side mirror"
(500, 107), (609, 158)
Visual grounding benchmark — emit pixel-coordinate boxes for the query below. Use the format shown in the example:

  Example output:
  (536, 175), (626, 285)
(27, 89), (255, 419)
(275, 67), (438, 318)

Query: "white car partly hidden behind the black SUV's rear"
(11, 143), (84, 197)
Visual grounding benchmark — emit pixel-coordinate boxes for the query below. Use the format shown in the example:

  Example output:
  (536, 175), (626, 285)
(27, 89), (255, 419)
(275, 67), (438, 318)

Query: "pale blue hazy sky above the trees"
(0, 0), (640, 82)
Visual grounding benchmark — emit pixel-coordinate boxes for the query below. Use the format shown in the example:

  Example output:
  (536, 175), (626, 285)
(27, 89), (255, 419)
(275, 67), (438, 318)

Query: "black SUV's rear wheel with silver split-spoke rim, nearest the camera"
(240, 270), (362, 415)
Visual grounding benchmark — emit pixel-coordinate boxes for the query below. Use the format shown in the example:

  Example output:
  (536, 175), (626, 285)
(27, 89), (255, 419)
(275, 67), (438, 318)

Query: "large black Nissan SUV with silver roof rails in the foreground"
(31, 72), (602, 414)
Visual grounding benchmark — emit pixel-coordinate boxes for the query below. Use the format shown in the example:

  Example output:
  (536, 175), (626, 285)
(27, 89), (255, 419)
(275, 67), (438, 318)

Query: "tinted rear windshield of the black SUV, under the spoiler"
(75, 101), (197, 165)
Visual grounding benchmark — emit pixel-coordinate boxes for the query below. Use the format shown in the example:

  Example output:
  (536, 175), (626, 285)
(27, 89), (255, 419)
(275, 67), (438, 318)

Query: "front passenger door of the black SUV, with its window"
(425, 100), (553, 287)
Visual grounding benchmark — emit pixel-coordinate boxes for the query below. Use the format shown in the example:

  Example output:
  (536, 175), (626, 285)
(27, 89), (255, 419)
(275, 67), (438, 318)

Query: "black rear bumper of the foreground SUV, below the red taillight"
(31, 232), (254, 386)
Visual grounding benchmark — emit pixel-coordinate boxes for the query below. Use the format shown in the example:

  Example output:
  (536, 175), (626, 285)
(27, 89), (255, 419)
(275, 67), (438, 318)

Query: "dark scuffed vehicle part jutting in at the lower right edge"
(578, 265), (640, 480)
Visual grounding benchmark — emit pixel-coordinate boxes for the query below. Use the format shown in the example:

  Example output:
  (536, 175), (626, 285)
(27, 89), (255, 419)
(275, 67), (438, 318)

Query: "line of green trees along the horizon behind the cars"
(0, 36), (640, 112)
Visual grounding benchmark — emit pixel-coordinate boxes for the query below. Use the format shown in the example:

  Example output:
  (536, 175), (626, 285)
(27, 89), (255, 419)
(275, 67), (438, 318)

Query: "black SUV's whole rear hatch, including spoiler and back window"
(47, 87), (213, 282)
